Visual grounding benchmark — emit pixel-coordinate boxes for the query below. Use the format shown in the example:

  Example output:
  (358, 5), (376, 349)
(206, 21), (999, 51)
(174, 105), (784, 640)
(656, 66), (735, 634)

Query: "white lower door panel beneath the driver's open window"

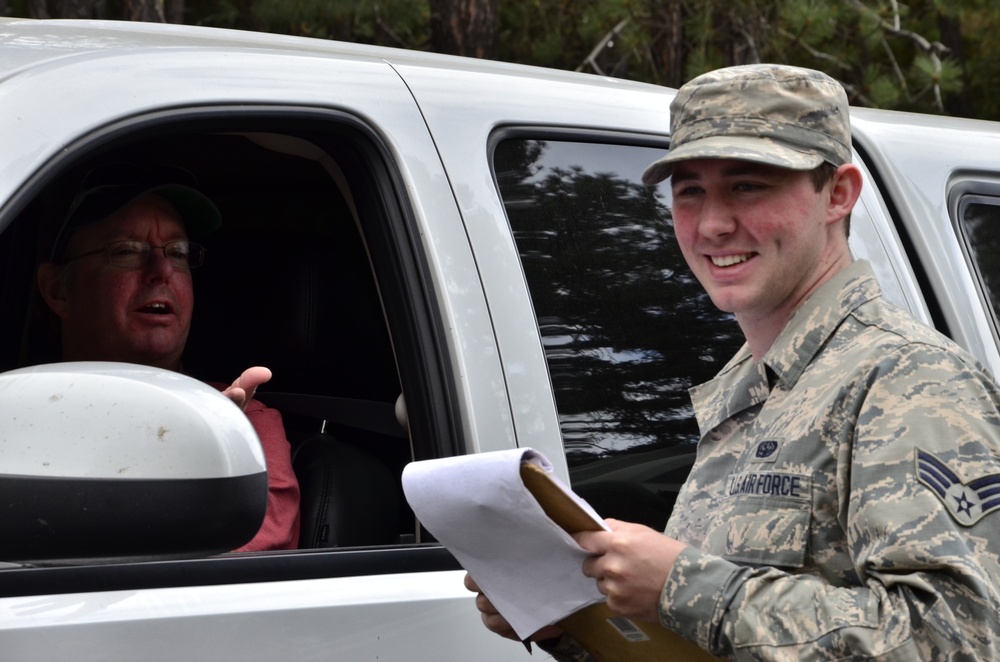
(0, 571), (519, 662)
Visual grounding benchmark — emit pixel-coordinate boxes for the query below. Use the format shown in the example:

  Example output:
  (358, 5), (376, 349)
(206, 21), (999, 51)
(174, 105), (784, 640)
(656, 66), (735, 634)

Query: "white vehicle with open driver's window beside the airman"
(0, 19), (1000, 662)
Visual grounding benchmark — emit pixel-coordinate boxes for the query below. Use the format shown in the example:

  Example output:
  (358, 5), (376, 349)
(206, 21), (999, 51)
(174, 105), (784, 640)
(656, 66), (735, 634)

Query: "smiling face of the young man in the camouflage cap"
(671, 159), (846, 324)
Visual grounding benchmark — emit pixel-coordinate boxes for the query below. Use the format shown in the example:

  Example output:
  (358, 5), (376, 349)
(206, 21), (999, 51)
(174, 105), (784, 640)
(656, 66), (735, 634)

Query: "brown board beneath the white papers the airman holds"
(521, 462), (720, 662)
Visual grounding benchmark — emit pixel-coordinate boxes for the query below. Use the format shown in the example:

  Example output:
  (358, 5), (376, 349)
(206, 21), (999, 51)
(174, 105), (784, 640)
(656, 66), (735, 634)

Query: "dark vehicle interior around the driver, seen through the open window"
(0, 118), (427, 548)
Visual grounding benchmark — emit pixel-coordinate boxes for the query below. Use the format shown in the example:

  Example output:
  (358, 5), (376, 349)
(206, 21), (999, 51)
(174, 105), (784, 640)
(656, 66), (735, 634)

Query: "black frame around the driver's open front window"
(0, 105), (464, 597)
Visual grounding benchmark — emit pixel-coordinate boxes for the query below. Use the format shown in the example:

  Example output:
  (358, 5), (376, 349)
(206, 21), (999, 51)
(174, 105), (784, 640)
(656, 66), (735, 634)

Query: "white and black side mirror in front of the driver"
(0, 362), (267, 563)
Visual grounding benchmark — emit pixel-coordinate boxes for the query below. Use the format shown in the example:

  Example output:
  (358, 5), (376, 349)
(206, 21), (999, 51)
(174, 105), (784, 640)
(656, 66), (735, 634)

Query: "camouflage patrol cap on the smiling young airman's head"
(642, 64), (851, 184)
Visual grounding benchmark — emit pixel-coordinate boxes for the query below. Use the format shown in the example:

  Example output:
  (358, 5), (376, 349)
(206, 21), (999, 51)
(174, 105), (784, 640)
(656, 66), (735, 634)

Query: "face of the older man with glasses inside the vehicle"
(50, 196), (194, 370)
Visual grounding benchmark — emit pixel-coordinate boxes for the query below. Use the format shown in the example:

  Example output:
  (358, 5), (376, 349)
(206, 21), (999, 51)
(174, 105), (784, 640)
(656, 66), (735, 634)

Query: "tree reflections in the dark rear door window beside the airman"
(495, 140), (742, 466)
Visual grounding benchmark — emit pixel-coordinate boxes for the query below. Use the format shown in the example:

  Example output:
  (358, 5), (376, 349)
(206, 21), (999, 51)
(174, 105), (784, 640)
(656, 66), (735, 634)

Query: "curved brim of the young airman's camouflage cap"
(642, 136), (824, 185)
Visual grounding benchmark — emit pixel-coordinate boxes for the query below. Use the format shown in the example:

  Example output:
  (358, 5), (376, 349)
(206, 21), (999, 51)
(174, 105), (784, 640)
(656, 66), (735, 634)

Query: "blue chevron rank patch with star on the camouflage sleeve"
(915, 448), (1000, 526)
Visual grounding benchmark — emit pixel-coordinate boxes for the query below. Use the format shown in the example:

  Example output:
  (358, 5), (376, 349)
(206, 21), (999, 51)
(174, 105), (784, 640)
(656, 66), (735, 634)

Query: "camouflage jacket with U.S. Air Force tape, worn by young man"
(660, 262), (1000, 662)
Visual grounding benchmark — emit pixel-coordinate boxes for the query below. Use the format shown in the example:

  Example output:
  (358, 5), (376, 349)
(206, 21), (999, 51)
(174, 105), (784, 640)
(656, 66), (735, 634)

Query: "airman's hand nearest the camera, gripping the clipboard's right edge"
(573, 519), (686, 623)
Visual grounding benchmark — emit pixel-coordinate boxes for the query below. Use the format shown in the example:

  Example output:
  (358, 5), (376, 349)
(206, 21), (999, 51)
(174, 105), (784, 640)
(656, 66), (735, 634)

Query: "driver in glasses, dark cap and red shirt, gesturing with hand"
(38, 164), (299, 551)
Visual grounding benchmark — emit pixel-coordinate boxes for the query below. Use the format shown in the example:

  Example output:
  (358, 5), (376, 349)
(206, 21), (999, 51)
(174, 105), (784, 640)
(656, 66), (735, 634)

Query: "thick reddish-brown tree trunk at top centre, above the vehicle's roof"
(430, 0), (499, 59)
